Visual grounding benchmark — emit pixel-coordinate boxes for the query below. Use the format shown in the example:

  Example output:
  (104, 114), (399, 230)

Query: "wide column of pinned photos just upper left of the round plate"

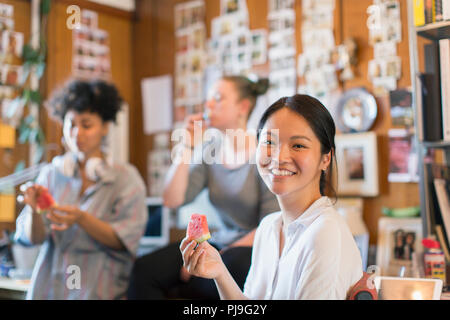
(297, 0), (339, 107)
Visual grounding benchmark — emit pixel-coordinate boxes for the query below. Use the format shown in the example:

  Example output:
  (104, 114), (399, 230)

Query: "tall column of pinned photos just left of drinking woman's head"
(174, 0), (206, 128)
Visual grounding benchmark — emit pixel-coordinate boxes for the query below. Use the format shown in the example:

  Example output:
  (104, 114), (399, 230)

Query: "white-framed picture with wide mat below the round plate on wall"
(335, 132), (379, 197)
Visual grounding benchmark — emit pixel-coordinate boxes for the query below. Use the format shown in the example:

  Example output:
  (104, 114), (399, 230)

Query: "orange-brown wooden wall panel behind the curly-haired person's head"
(45, 0), (136, 160)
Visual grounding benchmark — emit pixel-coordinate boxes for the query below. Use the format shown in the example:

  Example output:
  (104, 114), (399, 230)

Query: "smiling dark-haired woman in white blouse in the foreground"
(180, 95), (363, 300)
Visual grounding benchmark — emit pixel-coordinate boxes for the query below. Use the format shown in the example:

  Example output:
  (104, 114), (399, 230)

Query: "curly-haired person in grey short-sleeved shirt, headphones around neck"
(16, 80), (147, 299)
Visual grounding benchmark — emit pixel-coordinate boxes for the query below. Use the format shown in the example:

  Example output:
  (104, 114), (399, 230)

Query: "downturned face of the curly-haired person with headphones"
(63, 110), (108, 158)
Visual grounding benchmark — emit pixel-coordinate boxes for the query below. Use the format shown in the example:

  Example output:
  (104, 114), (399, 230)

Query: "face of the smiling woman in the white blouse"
(256, 107), (331, 198)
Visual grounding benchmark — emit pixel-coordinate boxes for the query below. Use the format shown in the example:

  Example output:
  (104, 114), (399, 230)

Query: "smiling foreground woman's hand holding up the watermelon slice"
(180, 237), (226, 279)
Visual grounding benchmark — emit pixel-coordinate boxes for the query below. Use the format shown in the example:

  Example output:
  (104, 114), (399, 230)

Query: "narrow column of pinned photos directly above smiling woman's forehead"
(267, 0), (297, 102)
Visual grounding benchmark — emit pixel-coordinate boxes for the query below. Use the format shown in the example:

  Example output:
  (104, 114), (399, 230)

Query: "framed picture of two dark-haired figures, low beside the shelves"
(377, 217), (423, 277)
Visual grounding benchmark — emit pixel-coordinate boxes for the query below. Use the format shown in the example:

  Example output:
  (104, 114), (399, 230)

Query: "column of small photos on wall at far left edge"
(0, 3), (24, 127)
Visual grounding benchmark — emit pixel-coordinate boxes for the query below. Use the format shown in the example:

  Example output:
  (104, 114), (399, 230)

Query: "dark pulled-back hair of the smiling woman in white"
(257, 94), (337, 199)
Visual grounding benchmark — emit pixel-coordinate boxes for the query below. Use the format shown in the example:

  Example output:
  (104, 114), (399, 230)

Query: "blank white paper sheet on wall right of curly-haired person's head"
(141, 75), (172, 134)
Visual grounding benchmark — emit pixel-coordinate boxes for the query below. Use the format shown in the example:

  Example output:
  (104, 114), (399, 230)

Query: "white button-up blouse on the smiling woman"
(244, 197), (363, 300)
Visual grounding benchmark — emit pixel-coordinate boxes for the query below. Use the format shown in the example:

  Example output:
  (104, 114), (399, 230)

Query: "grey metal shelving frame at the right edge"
(408, 1), (450, 237)
